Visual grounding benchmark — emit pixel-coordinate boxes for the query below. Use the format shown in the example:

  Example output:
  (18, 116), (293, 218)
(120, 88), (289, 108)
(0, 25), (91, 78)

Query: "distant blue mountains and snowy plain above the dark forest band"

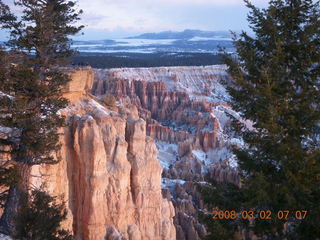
(72, 30), (234, 54)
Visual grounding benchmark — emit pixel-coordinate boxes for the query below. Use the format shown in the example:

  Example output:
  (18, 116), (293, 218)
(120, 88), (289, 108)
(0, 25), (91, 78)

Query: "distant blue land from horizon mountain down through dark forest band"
(72, 29), (234, 68)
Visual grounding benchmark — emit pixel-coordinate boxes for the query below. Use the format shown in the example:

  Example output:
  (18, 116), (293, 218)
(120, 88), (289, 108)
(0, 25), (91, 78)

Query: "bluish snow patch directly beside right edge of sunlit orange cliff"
(156, 141), (178, 168)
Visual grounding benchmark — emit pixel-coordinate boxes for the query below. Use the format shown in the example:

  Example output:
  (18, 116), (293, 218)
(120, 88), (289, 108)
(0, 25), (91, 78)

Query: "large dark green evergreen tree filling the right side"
(202, 0), (320, 239)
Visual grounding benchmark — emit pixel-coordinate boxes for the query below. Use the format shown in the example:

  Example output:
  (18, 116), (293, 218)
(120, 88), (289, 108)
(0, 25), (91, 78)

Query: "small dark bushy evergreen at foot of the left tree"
(14, 190), (73, 240)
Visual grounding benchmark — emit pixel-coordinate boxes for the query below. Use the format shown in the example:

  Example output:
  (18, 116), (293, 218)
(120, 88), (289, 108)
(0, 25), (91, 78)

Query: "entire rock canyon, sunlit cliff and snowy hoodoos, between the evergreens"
(0, 65), (242, 240)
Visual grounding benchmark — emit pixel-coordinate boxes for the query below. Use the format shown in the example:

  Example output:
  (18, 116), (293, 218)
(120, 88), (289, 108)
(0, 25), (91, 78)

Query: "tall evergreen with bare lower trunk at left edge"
(0, 0), (82, 233)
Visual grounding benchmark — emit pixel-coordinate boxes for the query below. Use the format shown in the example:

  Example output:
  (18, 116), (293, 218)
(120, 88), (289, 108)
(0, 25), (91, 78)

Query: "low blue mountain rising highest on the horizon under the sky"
(128, 29), (231, 39)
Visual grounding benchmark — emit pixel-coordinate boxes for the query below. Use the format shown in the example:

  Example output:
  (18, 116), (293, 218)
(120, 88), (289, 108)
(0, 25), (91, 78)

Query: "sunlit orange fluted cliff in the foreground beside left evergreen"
(31, 70), (175, 240)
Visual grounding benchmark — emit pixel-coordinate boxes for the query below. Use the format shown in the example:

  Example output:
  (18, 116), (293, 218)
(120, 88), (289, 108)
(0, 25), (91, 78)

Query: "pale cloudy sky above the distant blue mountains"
(0, 0), (268, 40)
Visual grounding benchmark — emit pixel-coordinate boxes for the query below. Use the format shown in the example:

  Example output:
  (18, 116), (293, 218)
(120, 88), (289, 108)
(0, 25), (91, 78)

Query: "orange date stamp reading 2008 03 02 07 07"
(212, 210), (308, 220)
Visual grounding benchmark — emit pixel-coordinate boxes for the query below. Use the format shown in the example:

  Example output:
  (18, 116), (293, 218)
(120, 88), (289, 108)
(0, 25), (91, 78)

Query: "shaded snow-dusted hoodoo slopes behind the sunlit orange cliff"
(91, 66), (239, 240)
